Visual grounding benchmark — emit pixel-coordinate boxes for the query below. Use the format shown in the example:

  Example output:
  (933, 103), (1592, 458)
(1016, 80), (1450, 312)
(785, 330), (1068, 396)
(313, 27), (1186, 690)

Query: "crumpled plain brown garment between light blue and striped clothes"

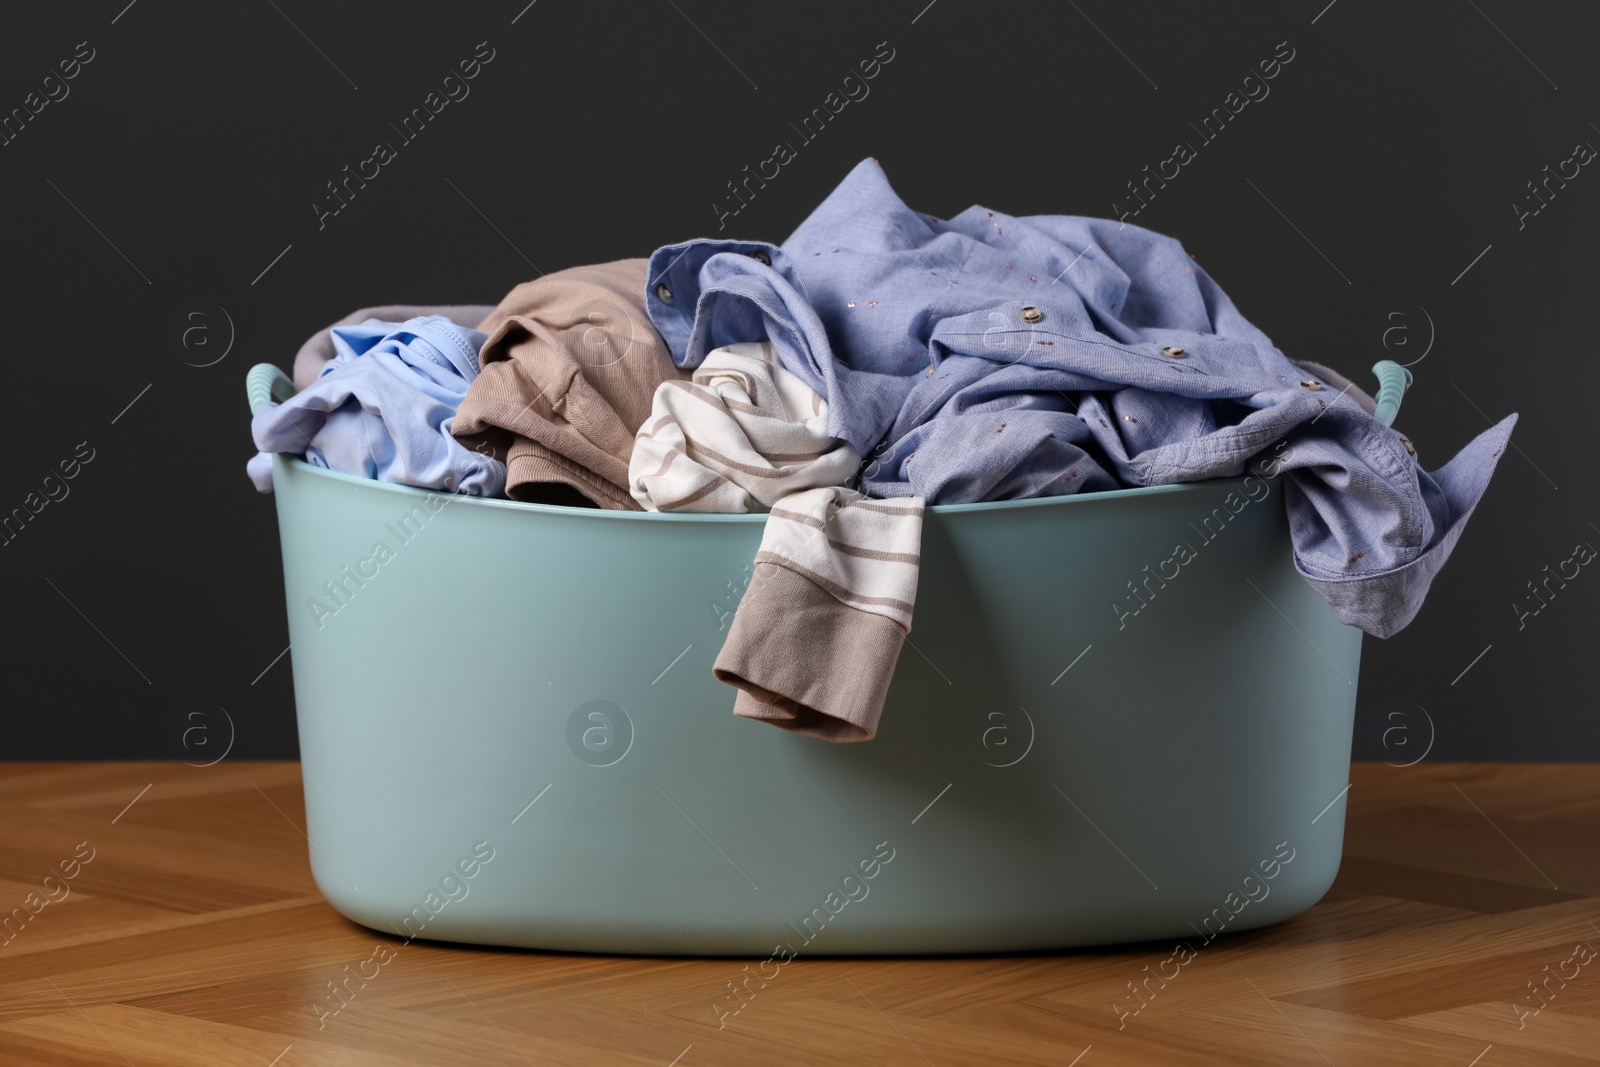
(453, 259), (690, 512)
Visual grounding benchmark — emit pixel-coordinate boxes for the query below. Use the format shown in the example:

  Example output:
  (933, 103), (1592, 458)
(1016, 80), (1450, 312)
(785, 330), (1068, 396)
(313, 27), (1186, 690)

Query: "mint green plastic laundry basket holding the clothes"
(250, 365), (1362, 958)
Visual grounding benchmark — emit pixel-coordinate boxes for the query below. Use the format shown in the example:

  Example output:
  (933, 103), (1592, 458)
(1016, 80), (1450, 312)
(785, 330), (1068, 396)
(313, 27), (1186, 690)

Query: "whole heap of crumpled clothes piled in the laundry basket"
(250, 160), (1517, 741)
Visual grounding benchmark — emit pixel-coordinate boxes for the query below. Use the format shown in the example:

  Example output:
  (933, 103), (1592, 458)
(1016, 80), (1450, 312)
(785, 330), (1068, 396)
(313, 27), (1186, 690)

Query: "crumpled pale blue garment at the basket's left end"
(248, 315), (506, 496)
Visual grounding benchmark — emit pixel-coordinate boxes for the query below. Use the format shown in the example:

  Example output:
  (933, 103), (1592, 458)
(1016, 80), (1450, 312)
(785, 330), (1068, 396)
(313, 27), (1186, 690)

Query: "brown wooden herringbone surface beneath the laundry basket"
(0, 763), (1600, 1067)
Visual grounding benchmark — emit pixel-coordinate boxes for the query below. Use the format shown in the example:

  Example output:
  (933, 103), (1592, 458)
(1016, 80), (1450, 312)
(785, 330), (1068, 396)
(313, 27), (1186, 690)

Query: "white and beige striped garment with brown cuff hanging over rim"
(629, 342), (923, 741)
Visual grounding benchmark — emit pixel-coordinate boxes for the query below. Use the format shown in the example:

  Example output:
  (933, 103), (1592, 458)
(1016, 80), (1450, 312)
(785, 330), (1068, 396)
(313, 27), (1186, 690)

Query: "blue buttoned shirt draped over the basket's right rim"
(645, 160), (1515, 637)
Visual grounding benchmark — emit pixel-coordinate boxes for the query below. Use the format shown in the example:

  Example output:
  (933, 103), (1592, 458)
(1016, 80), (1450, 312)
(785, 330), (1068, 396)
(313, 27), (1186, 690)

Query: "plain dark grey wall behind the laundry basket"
(0, 0), (1600, 761)
